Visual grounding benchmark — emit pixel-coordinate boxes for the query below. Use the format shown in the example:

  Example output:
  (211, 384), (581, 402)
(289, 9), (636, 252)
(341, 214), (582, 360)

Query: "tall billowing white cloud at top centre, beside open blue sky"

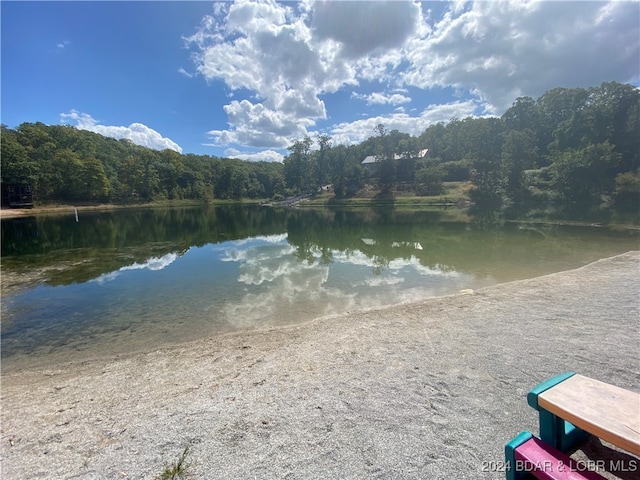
(186, 1), (353, 149)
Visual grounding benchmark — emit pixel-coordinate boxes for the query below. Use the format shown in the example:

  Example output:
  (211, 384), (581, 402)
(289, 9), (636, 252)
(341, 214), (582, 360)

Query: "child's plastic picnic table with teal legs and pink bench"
(505, 372), (640, 480)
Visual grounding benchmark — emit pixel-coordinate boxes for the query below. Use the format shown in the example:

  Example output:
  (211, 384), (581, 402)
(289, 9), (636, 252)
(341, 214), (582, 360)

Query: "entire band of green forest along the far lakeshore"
(0, 82), (640, 215)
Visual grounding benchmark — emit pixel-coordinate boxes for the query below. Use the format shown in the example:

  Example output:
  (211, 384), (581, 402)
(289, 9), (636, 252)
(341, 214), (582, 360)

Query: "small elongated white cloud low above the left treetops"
(60, 110), (182, 153)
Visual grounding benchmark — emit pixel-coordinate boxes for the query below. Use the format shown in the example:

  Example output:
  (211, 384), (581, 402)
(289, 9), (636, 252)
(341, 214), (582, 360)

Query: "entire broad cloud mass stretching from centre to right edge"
(183, 0), (640, 150)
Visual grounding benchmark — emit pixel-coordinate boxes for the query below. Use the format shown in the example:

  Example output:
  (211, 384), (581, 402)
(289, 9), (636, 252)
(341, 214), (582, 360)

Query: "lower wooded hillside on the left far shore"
(1, 122), (284, 203)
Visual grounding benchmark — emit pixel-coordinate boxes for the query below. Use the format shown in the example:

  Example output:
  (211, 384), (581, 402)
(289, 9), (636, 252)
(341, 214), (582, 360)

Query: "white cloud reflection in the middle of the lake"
(212, 235), (465, 328)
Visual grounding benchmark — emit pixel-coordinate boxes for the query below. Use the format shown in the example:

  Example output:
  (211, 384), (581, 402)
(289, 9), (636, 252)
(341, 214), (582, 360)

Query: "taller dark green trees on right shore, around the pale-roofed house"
(284, 82), (640, 216)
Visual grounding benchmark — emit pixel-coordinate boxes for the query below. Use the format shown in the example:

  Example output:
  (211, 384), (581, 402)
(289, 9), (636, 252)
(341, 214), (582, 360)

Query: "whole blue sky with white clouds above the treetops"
(0, 0), (640, 161)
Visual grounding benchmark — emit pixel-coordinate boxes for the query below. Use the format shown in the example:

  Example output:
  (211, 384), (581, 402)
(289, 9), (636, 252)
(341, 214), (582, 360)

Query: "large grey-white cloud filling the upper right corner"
(401, 1), (640, 114)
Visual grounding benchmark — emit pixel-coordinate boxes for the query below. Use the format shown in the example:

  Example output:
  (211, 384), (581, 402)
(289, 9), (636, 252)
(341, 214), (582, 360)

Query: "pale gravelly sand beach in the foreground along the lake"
(1, 252), (640, 480)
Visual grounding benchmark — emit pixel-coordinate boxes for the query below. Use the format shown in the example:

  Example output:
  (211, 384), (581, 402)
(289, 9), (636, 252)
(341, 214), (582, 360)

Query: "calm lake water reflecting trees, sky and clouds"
(1, 207), (640, 371)
